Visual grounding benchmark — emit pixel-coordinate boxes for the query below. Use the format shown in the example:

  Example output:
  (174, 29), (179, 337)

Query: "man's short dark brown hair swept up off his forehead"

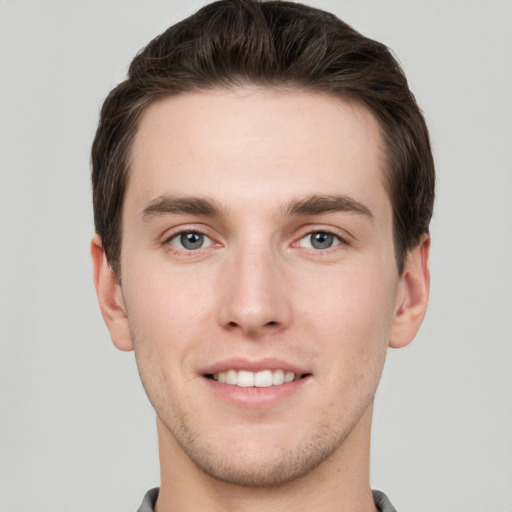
(92, 0), (435, 279)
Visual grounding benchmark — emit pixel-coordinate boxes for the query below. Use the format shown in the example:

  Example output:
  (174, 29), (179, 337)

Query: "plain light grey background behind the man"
(0, 0), (512, 512)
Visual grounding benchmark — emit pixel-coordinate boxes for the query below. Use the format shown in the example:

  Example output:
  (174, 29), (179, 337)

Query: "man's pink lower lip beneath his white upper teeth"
(203, 376), (311, 409)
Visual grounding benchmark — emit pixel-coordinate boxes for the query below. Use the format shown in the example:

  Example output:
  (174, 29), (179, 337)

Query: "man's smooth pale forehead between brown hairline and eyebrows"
(126, 87), (387, 218)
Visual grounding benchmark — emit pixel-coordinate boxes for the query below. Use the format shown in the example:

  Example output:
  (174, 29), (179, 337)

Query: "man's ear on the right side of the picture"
(389, 235), (430, 348)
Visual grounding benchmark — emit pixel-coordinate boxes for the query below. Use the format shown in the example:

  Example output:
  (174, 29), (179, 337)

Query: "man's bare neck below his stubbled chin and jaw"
(157, 406), (376, 512)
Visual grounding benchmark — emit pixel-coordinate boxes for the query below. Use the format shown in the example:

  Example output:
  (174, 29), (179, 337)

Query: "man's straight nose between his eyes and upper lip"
(219, 242), (292, 338)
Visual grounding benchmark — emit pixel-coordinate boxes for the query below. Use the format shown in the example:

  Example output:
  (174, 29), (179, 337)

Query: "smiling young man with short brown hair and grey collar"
(91, 0), (434, 512)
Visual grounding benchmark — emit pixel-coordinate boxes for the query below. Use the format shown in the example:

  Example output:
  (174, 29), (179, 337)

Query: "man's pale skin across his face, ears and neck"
(91, 87), (430, 512)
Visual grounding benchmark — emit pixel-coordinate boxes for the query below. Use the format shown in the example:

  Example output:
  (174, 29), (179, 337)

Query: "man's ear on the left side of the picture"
(91, 234), (133, 350)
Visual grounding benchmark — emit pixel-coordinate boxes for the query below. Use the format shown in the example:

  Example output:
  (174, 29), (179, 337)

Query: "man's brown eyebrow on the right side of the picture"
(284, 195), (374, 221)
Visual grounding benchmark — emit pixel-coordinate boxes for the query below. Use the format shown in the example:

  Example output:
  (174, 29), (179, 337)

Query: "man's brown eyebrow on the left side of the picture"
(141, 195), (226, 220)
